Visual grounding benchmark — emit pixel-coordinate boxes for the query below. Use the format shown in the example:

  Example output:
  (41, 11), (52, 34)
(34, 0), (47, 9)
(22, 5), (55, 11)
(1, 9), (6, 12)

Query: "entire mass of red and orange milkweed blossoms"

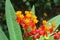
(16, 11), (60, 40)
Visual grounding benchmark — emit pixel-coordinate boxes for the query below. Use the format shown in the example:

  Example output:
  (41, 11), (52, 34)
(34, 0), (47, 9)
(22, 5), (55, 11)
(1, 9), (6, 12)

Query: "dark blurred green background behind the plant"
(0, 0), (60, 37)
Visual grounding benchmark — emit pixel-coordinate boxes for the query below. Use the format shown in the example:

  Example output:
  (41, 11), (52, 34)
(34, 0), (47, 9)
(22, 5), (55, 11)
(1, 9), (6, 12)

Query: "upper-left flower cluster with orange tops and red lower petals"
(16, 11), (38, 31)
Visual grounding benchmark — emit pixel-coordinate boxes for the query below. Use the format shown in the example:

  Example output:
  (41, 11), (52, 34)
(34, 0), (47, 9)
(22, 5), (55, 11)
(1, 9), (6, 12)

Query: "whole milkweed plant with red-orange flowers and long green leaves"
(0, 0), (60, 40)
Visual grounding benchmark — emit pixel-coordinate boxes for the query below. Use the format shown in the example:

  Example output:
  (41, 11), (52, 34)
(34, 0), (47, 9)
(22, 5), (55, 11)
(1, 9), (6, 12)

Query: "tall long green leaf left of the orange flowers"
(5, 0), (23, 40)
